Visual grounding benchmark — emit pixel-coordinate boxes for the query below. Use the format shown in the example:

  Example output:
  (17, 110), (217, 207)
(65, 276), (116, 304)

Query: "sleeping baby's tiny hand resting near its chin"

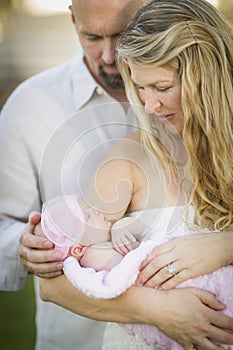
(111, 227), (139, 255)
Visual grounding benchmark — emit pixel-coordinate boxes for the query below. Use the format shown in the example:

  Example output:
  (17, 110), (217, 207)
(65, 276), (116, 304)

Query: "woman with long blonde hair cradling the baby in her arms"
(39, 0), (233, 350)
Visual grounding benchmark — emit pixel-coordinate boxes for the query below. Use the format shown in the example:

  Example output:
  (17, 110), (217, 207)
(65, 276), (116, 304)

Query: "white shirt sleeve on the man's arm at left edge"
(0, 85), (40, 290)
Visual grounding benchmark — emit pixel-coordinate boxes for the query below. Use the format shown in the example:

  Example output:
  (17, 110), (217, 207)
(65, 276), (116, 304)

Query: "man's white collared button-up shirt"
(0, 49), (137, 350)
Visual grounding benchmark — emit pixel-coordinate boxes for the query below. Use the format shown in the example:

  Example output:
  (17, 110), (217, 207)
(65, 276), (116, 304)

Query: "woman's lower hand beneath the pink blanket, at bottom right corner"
(151, 288), (233, 350)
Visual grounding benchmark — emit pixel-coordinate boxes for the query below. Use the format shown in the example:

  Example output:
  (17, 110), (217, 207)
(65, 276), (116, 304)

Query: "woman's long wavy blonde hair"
(117, 0), (233, 230)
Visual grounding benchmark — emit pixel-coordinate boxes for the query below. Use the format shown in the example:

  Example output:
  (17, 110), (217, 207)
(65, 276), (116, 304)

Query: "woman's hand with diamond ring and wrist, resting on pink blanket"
(136, 232), (233, 289)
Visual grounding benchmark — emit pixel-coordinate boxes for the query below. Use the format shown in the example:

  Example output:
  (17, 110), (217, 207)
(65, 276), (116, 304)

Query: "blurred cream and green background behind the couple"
(0, 0), (233, 350)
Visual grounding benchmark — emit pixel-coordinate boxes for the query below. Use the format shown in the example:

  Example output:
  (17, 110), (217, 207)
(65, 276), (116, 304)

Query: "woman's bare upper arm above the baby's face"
(83, 133), (144, 222)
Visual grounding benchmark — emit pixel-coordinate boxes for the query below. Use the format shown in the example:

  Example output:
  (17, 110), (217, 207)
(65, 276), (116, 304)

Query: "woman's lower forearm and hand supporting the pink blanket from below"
(40, 276), (233, 350)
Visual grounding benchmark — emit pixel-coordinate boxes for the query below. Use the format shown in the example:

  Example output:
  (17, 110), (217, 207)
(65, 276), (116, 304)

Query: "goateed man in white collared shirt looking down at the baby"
(0, 0), (145, 350)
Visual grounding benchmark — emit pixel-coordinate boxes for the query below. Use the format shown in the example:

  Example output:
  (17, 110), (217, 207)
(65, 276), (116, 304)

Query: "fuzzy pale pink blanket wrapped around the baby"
(64, 240), (233, 350)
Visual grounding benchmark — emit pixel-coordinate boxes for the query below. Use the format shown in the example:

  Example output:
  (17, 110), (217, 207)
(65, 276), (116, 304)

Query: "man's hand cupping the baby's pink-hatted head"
(18, 212), (63, 278)
